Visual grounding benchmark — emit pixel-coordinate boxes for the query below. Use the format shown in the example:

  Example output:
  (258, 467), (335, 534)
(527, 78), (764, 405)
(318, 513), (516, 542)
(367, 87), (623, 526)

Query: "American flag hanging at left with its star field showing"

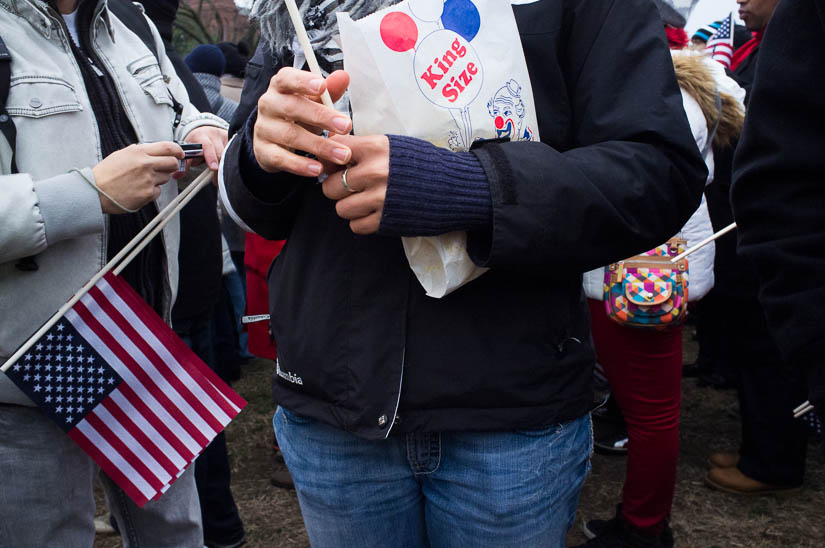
(7, 274), (246, 506)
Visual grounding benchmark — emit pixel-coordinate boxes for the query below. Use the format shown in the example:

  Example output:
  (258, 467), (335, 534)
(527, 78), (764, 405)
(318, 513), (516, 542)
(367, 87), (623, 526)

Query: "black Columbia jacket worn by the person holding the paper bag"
(224, 0), (707, 438)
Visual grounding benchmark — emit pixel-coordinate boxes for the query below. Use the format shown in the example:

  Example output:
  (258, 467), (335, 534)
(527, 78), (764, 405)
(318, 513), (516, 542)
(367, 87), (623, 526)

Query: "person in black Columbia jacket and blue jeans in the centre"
(221, 0), (707, 547)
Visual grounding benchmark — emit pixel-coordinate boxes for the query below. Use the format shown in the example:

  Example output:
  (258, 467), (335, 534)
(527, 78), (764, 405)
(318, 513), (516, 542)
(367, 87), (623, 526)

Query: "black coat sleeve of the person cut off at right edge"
(731, 0), (825, 366)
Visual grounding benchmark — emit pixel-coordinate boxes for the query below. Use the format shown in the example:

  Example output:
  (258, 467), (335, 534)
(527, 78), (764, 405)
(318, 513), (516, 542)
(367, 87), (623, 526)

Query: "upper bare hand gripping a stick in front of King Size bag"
(252, 67), (352, 177)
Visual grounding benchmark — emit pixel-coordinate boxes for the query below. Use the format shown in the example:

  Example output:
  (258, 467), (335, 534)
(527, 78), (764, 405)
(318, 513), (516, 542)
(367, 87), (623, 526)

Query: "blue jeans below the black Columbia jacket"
(273, 407), (593, 548)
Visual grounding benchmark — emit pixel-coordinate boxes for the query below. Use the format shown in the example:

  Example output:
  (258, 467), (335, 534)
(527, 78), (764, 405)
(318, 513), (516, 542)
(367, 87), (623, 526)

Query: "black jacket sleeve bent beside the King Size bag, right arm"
(468, 0), (707, 273)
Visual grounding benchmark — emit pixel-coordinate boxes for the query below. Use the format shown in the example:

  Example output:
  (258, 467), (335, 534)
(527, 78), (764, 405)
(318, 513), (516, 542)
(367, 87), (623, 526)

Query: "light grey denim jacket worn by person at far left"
(0, 0), (226, 405)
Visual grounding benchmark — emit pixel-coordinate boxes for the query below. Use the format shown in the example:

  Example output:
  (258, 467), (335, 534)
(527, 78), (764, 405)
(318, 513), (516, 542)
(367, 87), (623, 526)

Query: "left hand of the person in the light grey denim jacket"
(92, 141), (183, 214)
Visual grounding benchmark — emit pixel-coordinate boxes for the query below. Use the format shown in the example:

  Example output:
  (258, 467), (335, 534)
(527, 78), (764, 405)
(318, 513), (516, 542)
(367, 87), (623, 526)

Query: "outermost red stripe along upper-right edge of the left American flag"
(104, 274), (246, 412)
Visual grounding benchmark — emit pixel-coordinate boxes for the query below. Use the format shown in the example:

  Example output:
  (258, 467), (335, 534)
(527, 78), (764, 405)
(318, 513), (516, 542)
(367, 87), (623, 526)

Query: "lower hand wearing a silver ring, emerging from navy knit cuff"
(323, 135), (390, 234)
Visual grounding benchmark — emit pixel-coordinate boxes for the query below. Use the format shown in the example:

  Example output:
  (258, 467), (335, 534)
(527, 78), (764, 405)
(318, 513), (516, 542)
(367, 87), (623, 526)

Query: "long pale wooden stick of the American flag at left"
(0, 169), (212, 372)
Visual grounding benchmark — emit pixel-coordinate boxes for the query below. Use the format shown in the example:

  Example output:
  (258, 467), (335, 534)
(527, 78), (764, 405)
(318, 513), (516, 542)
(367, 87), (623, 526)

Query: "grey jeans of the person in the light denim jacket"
(0, 405), (203, 548)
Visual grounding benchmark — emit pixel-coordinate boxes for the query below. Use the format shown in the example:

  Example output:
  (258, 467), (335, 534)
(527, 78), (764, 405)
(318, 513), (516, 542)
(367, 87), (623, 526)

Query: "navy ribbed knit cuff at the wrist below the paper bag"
(378, 135), (493, 236)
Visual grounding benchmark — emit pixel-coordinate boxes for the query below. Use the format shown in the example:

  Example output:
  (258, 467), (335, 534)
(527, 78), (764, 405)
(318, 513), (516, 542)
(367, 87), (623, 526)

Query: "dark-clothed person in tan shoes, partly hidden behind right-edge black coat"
(700, 0), (808, 495)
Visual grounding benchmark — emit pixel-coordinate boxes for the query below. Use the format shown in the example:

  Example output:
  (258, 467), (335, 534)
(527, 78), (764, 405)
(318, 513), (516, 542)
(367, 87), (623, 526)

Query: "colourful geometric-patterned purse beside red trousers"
(604, 238), (688, 329)
